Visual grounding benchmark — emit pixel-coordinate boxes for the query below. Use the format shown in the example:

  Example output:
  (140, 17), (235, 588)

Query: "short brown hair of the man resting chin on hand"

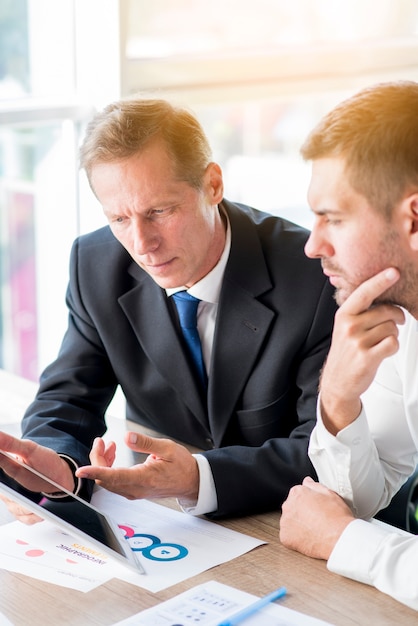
(301, 81), (418, 218)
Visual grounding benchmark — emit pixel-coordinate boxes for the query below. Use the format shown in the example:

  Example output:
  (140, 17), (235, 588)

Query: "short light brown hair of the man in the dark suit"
(80, 98), (212, 189)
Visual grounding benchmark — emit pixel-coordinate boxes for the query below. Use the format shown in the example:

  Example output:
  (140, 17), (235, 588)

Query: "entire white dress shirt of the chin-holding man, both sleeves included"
(309, 312), (418, 610)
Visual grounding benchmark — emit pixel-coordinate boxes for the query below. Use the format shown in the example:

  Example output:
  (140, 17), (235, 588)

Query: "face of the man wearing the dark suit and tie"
(91, 142), (225, 288)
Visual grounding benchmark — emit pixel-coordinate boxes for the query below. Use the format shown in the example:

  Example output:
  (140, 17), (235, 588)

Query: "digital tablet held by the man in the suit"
(0, 450), (145, 574)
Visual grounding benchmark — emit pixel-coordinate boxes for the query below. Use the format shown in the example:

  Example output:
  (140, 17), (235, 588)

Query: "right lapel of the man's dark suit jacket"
(208, 202), (276, 445)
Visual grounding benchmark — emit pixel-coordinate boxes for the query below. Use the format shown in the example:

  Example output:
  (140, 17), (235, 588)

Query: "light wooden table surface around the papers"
(0, 370), (417, 626)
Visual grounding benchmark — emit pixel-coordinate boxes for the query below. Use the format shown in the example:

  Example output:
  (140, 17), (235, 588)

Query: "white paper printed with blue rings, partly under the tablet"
(92, 489), (265, 592)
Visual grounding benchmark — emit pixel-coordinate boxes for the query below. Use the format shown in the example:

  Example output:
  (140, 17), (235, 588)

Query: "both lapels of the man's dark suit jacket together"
(119, 201), (277, 445)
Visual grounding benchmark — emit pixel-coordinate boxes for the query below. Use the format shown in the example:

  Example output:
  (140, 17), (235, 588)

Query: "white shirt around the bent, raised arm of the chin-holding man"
(309, 312), (418, 519)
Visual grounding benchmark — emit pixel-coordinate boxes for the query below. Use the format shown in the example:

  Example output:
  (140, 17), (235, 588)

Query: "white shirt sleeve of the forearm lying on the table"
(328, 520), (418, 610)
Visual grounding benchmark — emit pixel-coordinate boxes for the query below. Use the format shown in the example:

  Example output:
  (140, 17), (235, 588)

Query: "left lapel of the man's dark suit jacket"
(119, 264), (207, 427)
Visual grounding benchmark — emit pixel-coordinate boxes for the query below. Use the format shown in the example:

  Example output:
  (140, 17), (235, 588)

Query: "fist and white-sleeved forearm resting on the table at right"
(280, 479), (418, 610)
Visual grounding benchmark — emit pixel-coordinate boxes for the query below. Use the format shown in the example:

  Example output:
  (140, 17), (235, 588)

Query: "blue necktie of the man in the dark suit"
(172, 291), (208, 389)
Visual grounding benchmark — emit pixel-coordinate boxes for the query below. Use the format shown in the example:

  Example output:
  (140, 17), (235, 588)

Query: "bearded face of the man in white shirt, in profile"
(305, 158), (416, 308)
